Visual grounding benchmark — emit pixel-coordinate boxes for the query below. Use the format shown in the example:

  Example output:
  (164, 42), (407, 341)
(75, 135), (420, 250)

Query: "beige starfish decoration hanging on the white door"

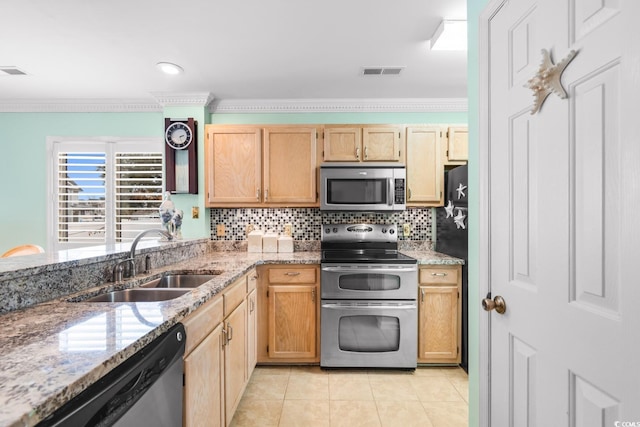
(524, 49), (578, 114)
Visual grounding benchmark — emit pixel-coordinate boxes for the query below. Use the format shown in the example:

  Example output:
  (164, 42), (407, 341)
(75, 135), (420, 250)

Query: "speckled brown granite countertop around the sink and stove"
(0, 251), (462, 427)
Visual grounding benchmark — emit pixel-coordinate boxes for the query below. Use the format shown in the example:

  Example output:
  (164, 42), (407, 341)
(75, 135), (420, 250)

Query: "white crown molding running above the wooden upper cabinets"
(209, 98), (468, 114)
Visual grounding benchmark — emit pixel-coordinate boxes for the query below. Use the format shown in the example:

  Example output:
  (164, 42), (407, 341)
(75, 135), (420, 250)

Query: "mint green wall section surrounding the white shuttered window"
(0, 112), (163, 253)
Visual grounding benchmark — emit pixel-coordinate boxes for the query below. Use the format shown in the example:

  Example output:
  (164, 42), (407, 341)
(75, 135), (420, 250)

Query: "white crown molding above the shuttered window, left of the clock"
(0, 99), (162, 113)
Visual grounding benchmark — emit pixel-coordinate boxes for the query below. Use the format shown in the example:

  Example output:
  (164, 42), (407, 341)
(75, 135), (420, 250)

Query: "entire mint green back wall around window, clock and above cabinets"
(0, 107), (467, 253)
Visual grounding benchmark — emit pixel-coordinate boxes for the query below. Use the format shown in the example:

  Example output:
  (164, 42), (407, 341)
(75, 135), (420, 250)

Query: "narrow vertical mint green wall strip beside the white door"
(467, 0), (488, 427)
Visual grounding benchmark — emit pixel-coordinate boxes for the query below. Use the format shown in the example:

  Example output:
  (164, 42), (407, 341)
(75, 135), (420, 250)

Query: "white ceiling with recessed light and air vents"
(0, 0), (466, 107)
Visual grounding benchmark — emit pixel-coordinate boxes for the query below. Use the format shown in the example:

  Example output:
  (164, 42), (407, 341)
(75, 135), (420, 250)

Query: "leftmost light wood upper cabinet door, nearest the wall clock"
(205, 126), (262, 207)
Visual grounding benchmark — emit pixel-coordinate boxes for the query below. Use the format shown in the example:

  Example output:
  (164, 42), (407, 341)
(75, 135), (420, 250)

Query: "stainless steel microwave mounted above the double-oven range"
(320, 163), (407, 212)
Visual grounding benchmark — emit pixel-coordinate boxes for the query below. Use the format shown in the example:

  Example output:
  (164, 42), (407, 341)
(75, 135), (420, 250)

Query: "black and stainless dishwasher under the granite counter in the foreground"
(38, 323), (186, 427)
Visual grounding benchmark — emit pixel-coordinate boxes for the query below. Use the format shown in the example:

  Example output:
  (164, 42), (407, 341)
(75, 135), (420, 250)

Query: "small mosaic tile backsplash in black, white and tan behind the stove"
(210, 208), (432, 242)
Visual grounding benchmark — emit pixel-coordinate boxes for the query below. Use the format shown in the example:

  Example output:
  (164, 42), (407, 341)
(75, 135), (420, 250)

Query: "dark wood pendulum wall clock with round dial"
(164, 118), (198, 194)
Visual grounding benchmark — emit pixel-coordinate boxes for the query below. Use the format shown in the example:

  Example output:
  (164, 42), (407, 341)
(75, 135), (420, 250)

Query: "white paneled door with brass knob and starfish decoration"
(477, 0), (640, 427)
